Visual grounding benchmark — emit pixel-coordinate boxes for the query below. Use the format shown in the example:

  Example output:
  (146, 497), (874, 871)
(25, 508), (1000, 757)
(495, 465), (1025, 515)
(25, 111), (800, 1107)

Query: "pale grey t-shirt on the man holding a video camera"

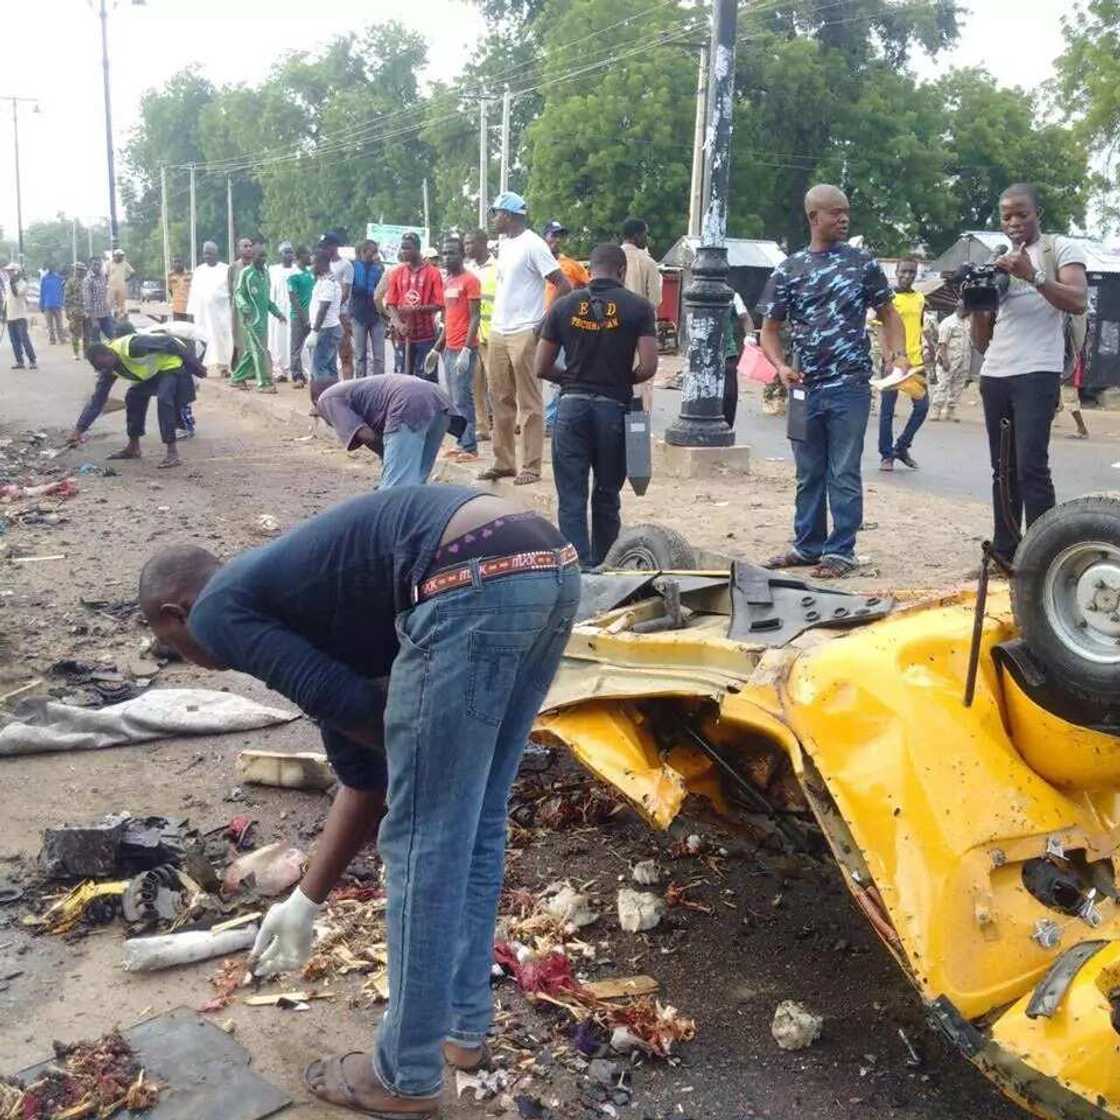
(981, 237), (1085, 377)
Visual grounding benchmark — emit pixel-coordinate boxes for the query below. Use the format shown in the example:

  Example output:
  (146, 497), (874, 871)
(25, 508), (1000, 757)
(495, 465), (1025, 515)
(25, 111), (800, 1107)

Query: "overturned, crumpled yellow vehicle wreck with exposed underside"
(535, 498), (1120, 1118)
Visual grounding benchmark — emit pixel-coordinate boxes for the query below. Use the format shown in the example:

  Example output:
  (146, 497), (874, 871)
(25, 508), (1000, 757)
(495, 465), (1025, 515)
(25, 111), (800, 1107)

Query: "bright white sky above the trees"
(0, 0), (1070, 240)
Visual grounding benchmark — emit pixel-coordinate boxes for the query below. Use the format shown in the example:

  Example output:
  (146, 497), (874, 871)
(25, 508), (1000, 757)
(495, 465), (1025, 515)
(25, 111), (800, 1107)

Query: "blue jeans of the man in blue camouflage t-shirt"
(791, 382), (871, 563)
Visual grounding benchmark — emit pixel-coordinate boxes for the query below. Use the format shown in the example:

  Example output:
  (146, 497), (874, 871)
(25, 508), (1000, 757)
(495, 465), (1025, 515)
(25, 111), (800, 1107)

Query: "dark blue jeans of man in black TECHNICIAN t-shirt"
(552, 393), (627, 568)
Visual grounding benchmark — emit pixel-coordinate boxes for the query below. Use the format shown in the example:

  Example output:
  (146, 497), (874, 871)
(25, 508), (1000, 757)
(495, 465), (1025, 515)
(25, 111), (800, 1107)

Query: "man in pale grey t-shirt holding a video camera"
(962, 183), (1088, 564)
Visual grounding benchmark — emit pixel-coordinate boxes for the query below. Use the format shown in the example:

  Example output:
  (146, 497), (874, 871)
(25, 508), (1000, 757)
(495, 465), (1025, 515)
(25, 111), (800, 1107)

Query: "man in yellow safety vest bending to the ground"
(67, 334), (206, 467)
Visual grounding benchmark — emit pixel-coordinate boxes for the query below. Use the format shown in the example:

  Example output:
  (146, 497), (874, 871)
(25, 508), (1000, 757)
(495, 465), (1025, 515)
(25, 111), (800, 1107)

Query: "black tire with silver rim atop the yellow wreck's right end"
(1011, 494), (1120, 706)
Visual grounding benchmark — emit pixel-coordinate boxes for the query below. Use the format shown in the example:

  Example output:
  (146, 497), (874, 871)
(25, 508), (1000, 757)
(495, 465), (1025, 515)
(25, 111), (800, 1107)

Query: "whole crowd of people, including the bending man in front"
(3, 176), (1086, 1117)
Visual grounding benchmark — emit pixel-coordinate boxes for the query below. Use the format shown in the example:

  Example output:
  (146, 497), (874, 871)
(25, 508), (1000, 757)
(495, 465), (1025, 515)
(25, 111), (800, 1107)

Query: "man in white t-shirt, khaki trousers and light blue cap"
(478, 190), (571, 486)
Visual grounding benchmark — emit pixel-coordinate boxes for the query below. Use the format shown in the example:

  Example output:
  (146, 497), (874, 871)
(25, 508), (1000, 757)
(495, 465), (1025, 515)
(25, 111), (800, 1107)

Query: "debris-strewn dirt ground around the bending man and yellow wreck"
(0, 327), (1023, 1120)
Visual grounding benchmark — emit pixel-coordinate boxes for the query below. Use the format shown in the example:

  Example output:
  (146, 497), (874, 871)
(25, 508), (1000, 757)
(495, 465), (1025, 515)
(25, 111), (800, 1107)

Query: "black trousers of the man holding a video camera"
(980, 373), (1061, 560)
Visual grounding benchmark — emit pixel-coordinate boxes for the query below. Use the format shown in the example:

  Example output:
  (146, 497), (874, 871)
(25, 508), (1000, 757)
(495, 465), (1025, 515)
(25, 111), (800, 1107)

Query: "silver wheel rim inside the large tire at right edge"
(1043, 541), (1120, 665)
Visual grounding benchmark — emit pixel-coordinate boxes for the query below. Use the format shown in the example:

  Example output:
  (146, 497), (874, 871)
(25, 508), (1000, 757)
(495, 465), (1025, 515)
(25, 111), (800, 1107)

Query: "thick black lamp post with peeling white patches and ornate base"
(665, 0), (738, 447)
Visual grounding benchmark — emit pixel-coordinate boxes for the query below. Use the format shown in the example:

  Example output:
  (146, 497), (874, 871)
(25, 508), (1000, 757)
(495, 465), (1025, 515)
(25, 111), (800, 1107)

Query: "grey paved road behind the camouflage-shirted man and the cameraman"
(653, 390), (1120, 502)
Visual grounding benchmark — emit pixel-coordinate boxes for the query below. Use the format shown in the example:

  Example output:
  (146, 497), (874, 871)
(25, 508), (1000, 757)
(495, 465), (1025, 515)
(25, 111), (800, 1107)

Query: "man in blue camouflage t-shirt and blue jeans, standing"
(762, 185), (909, 579)
